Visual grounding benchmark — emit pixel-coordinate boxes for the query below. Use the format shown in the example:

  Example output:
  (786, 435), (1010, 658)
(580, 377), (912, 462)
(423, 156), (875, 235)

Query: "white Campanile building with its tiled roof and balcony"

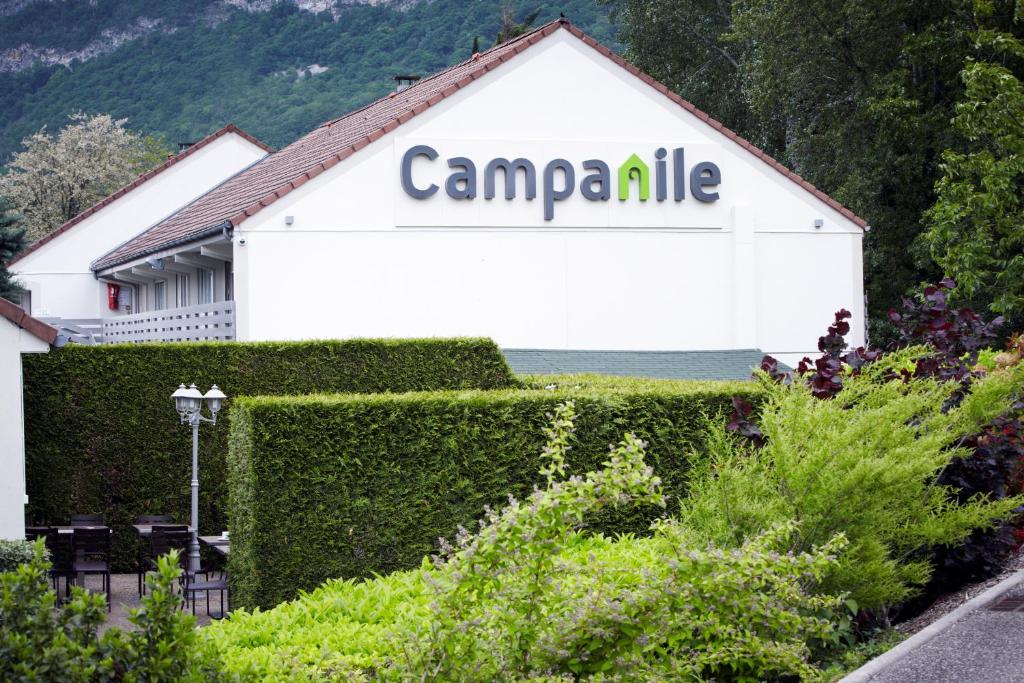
(14, 20), (866, 373)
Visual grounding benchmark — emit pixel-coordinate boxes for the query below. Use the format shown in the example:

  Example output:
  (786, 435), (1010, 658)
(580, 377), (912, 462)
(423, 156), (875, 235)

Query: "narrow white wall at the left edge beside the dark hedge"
(0, 317), (49, 539)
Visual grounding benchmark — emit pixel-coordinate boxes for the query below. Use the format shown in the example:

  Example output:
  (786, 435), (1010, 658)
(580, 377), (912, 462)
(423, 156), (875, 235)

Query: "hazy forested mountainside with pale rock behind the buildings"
(0, 0), (614, 160)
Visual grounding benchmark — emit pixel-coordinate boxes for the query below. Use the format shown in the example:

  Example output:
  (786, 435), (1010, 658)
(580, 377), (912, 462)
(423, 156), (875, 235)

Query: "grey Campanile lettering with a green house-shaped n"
(400, 144), (722, 221)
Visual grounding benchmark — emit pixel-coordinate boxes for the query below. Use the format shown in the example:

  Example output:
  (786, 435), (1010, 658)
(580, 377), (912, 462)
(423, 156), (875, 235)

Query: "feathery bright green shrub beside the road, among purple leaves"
(680, 348), (1024, 609)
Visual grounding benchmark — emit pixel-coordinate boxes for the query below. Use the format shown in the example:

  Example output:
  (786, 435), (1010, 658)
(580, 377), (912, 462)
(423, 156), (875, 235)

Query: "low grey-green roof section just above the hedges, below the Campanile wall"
(502, 348), (764, 380)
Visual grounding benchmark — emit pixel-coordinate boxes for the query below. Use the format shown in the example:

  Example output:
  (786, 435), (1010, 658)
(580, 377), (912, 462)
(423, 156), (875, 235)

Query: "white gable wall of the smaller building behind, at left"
(12, 133), (266, 318)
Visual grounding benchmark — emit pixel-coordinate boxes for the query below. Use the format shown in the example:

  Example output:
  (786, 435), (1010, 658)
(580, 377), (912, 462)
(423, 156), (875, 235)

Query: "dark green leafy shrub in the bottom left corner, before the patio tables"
(0, 541), (233, 683)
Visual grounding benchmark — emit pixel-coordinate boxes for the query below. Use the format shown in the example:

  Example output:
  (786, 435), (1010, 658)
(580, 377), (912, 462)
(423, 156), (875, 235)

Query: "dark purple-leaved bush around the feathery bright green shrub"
(728, 279), (1024, 612)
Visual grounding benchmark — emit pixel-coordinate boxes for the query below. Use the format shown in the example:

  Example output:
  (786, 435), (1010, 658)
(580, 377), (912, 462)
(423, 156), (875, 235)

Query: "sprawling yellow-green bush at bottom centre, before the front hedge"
(203, 404), (849, 681)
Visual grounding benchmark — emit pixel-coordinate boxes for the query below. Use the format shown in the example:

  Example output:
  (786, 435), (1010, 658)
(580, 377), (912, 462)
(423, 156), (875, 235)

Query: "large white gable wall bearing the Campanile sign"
(234, 32), (863, 358)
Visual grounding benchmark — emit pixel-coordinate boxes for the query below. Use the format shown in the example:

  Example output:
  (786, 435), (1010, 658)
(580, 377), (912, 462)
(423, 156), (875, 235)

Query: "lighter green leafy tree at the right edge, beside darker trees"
(924, 0), (1024, 318)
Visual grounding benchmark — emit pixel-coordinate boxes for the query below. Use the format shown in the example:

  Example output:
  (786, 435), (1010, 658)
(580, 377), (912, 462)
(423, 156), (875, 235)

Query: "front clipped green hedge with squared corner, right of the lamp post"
(228, 378), (756, 608)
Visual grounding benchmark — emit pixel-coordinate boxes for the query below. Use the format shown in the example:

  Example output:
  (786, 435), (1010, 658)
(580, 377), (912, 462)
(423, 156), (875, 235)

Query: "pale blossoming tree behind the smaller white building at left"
(0, 113), (167, 240)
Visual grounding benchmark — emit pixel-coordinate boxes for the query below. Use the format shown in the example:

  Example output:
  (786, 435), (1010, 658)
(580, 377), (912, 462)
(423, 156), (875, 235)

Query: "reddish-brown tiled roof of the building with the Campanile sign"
(93, 19), (867, 270)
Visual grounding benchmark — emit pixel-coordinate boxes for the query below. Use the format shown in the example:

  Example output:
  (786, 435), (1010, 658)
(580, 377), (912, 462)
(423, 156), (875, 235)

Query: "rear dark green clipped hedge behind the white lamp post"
(24, 339), (514, 570)
